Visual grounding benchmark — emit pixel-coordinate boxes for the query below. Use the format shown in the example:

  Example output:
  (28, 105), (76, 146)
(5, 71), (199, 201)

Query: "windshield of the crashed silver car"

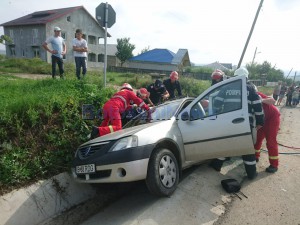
(123, 101), (182, 128)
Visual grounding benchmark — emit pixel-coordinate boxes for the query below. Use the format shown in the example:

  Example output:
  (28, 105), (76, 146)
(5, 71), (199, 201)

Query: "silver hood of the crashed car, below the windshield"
(82, 121), (166, 145)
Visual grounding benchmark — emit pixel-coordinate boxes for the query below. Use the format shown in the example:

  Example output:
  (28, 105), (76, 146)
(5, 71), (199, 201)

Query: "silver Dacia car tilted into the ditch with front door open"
(72, 76), (254, 196)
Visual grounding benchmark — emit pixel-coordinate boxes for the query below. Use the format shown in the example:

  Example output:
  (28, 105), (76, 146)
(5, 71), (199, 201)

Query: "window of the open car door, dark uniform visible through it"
(190, 80), (242, 120)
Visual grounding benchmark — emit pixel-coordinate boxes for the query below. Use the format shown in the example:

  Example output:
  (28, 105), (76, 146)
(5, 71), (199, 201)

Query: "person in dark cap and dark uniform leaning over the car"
(147, 80), (170, 105)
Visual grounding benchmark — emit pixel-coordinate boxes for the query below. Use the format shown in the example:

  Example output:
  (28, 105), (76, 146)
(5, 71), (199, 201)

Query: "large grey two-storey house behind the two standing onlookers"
(1, 6), (110, 68)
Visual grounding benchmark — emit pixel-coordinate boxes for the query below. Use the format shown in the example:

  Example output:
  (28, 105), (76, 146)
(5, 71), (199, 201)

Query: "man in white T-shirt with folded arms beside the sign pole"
(72, 29), (88, 80)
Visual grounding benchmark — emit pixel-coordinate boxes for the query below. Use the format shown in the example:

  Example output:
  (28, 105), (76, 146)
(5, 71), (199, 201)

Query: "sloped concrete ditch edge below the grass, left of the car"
(0, 173), (96, 225)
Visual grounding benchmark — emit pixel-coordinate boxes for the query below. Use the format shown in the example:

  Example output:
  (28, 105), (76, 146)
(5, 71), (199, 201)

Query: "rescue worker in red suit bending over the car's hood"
(91, 83), (149, 138)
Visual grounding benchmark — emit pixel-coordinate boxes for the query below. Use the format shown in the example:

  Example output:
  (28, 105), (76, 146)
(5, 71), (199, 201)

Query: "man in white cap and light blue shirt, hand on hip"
(42, 27), (67, 79)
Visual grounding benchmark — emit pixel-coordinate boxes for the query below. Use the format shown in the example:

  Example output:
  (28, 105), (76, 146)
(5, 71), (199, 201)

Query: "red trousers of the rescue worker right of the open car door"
(254, 116), (280, 168)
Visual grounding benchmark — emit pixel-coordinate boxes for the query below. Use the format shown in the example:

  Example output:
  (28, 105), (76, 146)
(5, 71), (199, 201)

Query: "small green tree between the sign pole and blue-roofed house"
(116, 38), (135, 66)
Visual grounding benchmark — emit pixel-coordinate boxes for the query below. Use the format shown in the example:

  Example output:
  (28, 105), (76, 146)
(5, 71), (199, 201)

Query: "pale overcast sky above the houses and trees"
(0, 0), (300, 75)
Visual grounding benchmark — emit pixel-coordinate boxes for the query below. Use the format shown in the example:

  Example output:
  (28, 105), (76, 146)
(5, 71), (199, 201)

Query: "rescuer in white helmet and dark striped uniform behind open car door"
(210, 67), (264, 179)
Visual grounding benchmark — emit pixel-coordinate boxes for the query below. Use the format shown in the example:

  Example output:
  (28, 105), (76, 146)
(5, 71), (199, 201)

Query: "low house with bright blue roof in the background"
(126, 48), (191, 72)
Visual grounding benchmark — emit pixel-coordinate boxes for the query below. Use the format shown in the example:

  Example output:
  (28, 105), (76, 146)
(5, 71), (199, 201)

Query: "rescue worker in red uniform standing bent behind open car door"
(254, 92), (280, 173)
